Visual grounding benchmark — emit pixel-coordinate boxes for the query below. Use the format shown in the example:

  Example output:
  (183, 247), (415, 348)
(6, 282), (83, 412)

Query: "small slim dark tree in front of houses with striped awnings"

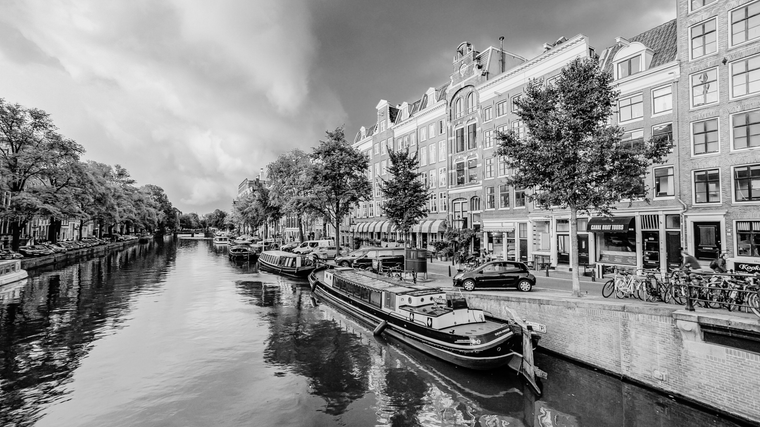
(380, 148), (430, 247)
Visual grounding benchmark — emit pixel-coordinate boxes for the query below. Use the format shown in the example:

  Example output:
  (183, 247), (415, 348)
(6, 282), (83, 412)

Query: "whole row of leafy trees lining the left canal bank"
(0, 98), (180, 249)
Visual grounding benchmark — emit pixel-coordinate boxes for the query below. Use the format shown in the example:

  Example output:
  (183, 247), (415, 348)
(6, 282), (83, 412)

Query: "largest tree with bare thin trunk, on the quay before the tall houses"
(496, 57), (670, 296)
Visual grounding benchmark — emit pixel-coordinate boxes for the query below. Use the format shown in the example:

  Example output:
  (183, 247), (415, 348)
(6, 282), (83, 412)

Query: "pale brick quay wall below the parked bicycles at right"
(466, 293), (760, 423)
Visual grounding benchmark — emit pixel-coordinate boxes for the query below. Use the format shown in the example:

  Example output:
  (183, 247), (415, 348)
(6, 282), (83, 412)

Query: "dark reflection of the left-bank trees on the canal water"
(0, 243), (173, 426)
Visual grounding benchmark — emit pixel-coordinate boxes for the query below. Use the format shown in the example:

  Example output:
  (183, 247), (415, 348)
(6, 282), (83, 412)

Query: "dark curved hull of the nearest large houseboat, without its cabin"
(309, 274), (522, 370)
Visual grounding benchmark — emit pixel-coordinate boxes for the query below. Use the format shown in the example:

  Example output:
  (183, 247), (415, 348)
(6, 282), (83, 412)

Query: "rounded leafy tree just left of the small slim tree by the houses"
(307, 127), (372, 244)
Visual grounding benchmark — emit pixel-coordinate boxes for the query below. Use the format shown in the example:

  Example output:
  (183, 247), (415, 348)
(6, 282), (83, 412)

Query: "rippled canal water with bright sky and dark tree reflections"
(0, 240), (748, 427)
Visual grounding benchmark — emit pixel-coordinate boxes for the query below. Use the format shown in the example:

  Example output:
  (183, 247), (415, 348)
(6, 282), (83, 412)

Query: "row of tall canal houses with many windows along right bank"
(341, 0), (760, 273)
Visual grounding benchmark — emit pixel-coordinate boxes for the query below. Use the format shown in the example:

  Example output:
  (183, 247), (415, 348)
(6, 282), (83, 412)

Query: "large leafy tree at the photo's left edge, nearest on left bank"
(0, 98), (84, 249)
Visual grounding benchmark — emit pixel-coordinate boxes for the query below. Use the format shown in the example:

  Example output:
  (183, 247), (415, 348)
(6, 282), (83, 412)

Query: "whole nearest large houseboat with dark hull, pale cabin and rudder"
(309, 267), (546, 394)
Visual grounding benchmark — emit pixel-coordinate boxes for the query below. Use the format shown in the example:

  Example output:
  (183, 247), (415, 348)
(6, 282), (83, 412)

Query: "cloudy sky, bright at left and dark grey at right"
(0, 0), (675, 214)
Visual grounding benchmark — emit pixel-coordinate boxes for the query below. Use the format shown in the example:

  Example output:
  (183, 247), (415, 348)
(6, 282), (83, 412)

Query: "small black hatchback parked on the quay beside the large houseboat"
(454, 261), (536, 292)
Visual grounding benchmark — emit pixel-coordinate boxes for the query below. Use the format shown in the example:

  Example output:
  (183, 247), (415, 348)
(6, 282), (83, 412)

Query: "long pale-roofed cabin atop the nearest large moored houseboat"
(325, 268), (485, 330)
